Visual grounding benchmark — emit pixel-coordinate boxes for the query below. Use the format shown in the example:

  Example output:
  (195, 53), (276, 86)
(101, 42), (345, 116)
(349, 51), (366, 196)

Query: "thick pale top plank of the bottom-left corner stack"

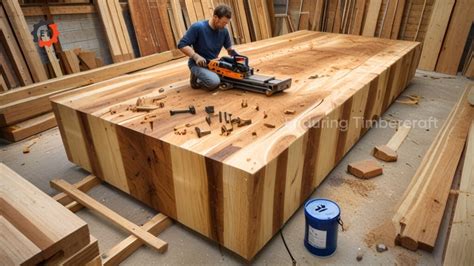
(0, 164), (90, 260)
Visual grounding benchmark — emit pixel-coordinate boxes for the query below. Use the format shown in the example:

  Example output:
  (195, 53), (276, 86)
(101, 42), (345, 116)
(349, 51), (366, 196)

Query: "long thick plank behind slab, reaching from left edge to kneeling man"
(0, 51), (182, 127)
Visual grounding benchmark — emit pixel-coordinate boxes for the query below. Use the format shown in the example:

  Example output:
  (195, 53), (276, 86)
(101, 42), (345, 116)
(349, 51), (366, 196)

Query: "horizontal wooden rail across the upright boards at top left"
(21, 4), (97, 17)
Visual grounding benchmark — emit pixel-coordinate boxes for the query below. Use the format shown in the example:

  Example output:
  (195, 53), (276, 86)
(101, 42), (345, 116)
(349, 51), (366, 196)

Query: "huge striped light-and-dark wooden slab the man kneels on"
(52, 31), (421, 260)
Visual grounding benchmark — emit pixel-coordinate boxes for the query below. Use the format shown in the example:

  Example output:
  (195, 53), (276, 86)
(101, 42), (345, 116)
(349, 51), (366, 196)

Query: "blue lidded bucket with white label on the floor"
(304, 199), (341, 257)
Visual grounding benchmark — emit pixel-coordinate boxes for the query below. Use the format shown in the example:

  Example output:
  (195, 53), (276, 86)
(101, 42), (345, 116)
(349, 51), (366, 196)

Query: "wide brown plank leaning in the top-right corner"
(436, 0), (474, 75)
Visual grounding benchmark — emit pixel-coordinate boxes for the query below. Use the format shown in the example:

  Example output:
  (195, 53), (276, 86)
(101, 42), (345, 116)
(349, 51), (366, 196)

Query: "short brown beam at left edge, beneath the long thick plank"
(0, 112), (56, 142)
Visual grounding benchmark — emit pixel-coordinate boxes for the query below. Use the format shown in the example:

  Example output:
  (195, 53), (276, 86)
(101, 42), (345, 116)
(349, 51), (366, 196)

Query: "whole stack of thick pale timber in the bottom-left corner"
(0, 163), (99, 265)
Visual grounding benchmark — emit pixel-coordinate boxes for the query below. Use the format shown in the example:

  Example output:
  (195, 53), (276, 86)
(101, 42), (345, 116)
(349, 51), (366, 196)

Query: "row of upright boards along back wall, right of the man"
(284, 0), (474, 75)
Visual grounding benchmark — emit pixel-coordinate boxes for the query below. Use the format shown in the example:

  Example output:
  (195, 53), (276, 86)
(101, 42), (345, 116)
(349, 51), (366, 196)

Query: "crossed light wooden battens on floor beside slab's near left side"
(51, 175), (172, 265)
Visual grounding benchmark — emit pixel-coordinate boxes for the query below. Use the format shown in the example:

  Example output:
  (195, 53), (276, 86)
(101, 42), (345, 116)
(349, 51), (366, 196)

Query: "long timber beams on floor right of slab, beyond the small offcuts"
(392, 84), (474, 251)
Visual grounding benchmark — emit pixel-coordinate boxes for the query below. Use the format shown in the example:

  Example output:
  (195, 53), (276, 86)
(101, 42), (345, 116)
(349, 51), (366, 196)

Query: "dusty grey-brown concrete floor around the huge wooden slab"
(0, 71), (472, 265)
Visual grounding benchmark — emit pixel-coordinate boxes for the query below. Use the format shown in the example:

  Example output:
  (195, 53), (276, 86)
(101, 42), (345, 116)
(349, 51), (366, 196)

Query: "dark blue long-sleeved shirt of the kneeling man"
(178, 20), (232, 66)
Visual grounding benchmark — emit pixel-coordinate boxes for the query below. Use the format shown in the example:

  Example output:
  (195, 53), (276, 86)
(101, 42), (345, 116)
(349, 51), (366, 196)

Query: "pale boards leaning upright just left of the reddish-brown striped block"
(94, 0), (133, 63)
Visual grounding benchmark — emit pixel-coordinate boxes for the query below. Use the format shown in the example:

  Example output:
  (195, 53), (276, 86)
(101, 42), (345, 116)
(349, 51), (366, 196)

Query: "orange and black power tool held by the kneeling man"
(207, 55), (291, 96)
